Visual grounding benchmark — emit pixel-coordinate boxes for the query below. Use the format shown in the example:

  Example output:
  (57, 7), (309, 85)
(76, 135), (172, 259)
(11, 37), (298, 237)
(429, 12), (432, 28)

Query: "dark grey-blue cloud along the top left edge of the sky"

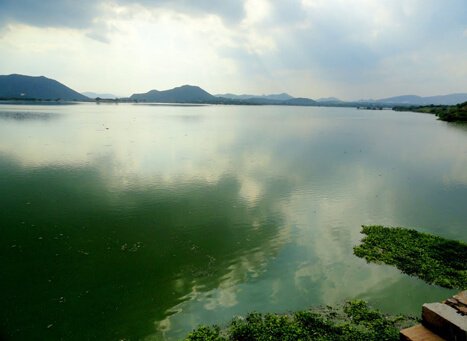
(0, 0), (244, 29)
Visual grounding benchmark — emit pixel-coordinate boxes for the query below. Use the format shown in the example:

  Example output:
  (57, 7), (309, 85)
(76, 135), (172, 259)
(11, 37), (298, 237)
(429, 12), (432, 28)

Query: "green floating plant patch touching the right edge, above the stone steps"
(354, 226), (467, 290)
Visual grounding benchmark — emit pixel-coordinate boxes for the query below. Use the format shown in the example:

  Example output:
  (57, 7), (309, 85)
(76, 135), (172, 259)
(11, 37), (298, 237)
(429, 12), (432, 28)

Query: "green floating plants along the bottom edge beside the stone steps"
(186, 300), (416, 341)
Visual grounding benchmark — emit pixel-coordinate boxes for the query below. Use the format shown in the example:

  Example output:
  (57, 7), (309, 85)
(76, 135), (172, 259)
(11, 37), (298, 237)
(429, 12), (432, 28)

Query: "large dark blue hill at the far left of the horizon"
(0, 74), (89, 101)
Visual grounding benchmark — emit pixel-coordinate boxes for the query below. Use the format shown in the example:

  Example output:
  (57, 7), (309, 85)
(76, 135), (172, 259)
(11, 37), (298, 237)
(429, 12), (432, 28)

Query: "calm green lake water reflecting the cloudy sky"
(0, 104), (467, 340)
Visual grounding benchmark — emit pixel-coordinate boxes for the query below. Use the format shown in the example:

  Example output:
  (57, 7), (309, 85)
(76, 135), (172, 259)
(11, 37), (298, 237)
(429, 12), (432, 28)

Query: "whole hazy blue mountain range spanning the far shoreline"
(0, 74), (467, 107)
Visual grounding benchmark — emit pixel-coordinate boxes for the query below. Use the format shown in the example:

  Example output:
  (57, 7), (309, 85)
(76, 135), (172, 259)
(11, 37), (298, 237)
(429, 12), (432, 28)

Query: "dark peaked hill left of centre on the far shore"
(130, 85), (220, 103)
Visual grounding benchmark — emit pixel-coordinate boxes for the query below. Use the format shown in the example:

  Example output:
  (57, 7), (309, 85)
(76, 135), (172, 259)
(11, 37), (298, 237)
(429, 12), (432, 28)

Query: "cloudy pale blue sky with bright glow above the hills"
(0, 0), (467, 100)
